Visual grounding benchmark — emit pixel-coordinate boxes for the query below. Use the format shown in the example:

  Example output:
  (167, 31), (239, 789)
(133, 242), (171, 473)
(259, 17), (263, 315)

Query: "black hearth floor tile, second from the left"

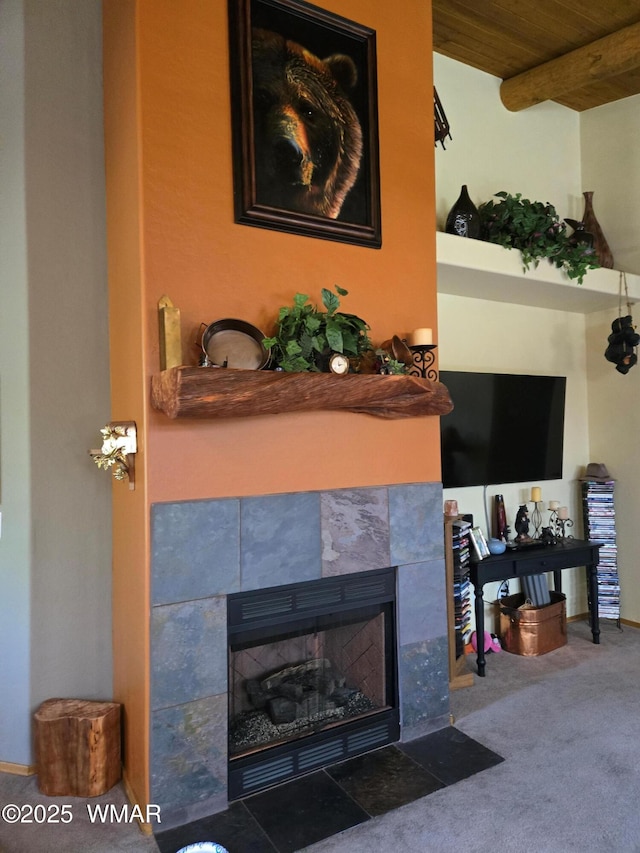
(243, 771), (369, 853)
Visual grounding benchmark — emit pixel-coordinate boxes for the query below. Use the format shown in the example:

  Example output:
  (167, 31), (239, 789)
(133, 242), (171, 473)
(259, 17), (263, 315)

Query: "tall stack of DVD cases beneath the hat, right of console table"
(581, 480), (620, 621)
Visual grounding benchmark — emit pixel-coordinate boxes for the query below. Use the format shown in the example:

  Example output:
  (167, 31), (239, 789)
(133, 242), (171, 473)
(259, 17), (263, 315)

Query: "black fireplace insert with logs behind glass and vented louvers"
(227, 568), (400, 800)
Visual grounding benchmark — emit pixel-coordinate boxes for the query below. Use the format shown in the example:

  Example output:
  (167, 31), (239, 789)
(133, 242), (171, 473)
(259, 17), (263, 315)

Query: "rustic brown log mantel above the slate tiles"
(151, 367), (453, 419)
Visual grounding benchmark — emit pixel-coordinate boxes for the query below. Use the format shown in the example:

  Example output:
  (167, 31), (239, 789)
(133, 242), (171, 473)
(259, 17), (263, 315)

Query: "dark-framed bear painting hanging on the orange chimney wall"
(229, 0), (382, 248)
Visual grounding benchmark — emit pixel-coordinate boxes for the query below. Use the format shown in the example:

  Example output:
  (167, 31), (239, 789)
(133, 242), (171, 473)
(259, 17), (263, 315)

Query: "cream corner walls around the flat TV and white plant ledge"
(434, 55), (640, 622)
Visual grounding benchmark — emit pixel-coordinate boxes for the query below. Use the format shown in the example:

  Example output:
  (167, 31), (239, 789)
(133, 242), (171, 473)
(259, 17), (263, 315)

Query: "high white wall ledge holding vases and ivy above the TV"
(436, 231), (640, 314)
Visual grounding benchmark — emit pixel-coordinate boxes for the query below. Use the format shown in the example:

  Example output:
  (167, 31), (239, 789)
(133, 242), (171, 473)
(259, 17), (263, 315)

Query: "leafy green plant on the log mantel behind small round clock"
(263, 285), (371, 372)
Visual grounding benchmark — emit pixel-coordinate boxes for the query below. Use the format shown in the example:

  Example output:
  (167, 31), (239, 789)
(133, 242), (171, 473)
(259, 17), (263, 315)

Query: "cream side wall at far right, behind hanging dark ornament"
(581, 96), (640, 622)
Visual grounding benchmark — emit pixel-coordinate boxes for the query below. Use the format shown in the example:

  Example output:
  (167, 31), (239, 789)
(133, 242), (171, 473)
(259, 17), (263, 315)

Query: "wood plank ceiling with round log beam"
(432, 0), (640, 111)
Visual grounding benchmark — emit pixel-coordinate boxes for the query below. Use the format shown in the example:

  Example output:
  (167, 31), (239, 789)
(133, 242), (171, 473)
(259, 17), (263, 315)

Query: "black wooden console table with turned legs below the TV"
(469, 539), (602, 676)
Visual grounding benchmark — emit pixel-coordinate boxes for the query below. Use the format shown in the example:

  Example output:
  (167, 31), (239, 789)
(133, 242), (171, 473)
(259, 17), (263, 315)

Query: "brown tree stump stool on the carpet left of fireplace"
(34, 699), (121, 797)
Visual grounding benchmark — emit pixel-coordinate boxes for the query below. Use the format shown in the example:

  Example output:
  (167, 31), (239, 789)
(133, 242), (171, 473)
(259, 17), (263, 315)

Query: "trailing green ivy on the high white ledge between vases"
(479, 191), (600, 284)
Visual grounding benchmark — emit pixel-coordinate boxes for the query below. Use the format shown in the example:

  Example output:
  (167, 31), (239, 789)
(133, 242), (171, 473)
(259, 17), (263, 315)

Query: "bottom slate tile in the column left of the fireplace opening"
(151, 694), (227, 809)
